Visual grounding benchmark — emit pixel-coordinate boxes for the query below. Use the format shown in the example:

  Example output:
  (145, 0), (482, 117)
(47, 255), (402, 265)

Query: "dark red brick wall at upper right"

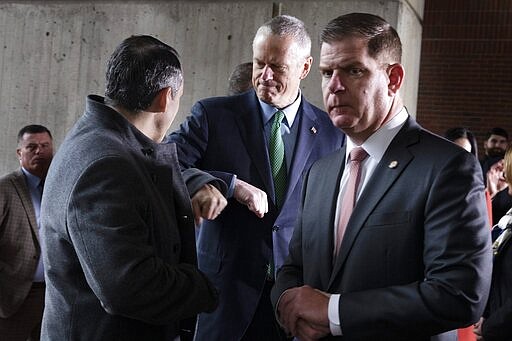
(417, 0), (512, 155)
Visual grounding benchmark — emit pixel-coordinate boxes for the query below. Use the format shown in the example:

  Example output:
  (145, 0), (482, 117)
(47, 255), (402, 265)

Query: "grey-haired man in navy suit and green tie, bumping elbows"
(169, 16), (343, 341)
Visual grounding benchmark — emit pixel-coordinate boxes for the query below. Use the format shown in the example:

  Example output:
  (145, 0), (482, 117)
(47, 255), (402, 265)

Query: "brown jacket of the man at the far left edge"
(0, 169), (41, 318)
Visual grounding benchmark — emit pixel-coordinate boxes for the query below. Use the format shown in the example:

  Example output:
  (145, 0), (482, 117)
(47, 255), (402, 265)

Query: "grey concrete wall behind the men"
(0, 0), (423, 174)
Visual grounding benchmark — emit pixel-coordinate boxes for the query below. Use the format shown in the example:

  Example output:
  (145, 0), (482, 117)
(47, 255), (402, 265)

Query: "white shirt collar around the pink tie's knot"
(345, 107), (409, 163)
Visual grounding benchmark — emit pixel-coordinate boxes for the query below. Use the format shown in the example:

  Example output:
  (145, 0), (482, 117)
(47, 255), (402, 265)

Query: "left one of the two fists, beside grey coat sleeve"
(192, 184), (228, 226)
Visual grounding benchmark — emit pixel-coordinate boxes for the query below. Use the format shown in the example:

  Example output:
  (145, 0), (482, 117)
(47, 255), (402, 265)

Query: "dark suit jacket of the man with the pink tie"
(272, 118), (492, 341)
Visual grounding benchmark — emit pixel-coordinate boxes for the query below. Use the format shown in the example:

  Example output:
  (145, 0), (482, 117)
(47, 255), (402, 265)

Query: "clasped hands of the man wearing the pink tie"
(277, 285), (330, 341)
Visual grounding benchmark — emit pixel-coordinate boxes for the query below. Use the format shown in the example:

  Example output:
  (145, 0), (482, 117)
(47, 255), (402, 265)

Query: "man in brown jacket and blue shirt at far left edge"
(0, 125), (53, 341)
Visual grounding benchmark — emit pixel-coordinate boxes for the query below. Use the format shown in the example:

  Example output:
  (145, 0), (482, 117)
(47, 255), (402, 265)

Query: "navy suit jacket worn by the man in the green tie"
(169, 90), (344, 341)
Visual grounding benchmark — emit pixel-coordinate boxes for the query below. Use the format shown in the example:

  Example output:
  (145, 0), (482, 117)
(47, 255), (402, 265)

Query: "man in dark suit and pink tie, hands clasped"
(272, 13), (492, 341)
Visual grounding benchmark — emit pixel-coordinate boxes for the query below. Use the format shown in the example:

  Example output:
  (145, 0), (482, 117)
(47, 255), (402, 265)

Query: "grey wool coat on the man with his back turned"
(41, 96), (224, 341)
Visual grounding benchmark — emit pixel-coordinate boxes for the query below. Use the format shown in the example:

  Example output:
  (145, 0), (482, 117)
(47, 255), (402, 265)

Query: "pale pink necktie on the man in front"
(335, 147), (368, 255)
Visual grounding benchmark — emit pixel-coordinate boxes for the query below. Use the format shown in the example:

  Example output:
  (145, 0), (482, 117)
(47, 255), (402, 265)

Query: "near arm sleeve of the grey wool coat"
(67, 157), (217, 324)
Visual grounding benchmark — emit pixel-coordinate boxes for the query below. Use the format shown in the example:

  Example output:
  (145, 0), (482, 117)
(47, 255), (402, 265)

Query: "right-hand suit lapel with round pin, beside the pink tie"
(329, 119), (418, 286)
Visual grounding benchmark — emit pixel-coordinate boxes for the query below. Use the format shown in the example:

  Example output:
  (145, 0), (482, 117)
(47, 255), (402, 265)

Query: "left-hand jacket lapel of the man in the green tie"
(235, 91), (274, 198)
